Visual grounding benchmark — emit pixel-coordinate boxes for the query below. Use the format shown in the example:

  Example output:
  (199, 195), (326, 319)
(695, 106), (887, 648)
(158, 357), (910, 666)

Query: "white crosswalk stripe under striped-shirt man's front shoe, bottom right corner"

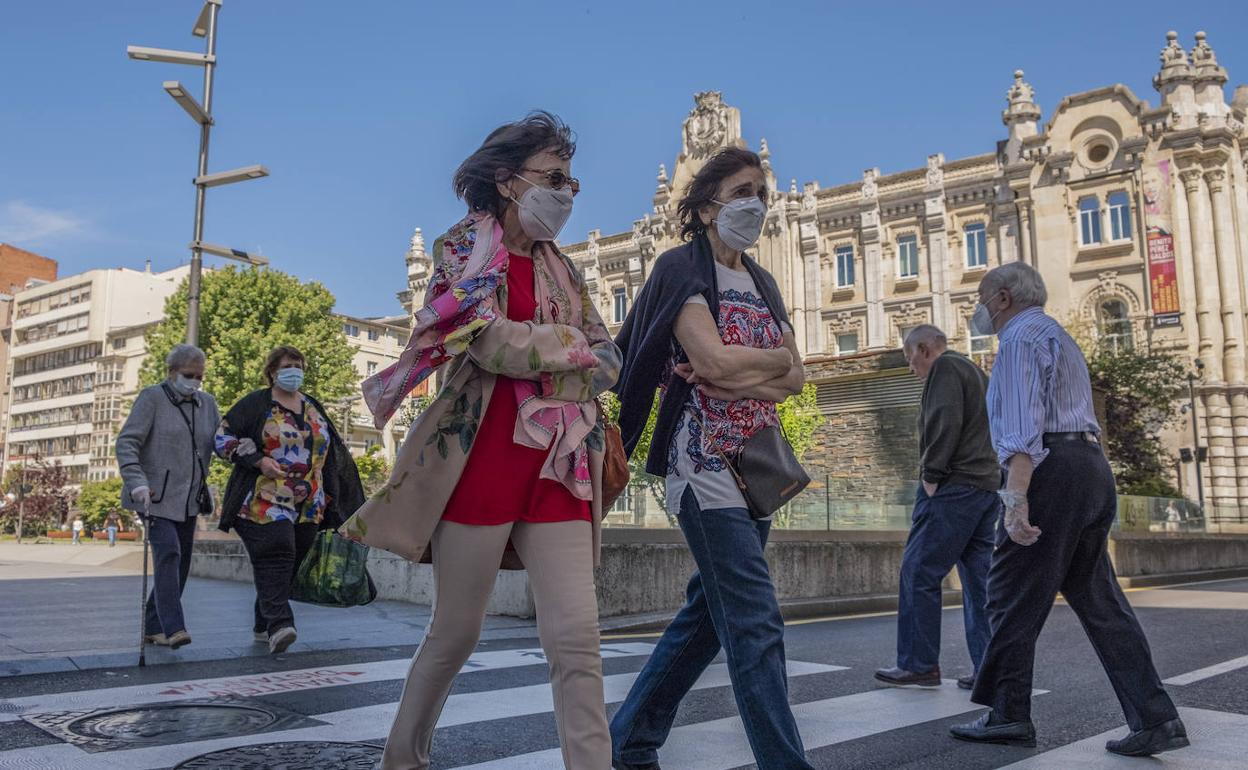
(1002, 708), (1248, 770)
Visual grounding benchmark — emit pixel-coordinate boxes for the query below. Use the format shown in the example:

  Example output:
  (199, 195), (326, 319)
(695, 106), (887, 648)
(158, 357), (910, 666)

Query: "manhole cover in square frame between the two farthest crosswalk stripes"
(22, 698), (324, 751)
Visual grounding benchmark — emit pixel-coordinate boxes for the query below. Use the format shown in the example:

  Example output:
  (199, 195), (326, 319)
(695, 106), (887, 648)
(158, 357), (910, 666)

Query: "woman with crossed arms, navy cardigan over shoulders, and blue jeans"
(612, 147), (810, 770)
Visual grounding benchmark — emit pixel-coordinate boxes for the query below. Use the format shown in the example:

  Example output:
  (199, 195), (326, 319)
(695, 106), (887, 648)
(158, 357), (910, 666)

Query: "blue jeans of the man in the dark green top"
(897, 484), (1001, 674)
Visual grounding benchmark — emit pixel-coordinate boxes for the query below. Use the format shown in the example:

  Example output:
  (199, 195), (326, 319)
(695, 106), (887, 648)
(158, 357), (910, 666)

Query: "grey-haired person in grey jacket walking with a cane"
(117, 344), (221, 649)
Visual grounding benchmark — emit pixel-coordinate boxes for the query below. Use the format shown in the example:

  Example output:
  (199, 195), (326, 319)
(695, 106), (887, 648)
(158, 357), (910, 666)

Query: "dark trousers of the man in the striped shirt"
(971, 442), (1178, 730)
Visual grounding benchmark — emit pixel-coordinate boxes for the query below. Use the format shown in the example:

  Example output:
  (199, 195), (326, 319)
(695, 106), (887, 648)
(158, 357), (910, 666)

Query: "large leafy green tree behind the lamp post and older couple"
(140, 267), (357, 502)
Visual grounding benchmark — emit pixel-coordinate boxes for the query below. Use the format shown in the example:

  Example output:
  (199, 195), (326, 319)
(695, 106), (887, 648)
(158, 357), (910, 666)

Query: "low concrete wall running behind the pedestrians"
(191, 530), (1248, 619)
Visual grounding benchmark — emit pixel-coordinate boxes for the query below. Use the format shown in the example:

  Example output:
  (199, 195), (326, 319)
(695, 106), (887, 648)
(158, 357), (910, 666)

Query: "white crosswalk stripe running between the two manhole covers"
(0, 660), (845, 770)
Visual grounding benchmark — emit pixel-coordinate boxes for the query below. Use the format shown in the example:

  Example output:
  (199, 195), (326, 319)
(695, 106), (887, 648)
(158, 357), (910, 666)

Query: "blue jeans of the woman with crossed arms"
(612, 489), (810, 770)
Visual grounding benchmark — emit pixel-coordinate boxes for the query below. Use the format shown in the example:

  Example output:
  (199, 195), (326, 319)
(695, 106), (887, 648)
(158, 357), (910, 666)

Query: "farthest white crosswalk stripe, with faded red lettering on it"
(0, 643), (654, 723)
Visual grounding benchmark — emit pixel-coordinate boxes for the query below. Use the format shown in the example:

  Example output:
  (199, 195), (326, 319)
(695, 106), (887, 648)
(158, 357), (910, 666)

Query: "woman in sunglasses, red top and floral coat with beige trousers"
(342, 112), (619, 770)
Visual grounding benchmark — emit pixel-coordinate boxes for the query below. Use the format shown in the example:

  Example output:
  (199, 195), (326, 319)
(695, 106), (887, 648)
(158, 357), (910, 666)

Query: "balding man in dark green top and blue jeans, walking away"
(875, 324), (1001, 690)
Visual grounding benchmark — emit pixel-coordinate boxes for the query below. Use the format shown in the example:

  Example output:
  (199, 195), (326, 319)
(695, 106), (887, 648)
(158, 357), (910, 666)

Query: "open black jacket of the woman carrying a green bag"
(218, 388), (364, 532)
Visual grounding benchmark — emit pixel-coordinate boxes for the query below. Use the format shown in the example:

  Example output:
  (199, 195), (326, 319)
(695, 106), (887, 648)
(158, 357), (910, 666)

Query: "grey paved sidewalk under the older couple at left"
(0, 543), (537, 678)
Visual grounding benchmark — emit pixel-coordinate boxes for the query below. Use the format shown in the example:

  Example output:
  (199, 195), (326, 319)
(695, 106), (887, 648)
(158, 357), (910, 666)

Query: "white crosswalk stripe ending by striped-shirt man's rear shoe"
(461, 680), (1042, 770)
